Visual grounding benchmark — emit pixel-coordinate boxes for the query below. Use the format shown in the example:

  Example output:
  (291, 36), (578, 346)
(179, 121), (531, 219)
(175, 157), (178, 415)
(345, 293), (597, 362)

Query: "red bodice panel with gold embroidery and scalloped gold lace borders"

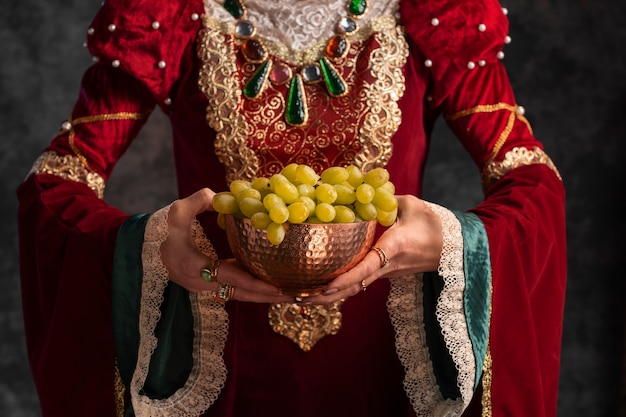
(198, 2), (408, 181)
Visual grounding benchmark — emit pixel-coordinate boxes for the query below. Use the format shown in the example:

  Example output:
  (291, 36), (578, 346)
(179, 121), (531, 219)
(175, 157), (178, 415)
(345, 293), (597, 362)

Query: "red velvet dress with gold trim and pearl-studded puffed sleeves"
(18, 0), (566, 416)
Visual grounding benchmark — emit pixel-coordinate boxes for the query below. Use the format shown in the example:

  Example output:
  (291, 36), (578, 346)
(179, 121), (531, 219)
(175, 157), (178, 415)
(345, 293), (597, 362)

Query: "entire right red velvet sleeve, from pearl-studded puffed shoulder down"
(401, 0), (566, 416)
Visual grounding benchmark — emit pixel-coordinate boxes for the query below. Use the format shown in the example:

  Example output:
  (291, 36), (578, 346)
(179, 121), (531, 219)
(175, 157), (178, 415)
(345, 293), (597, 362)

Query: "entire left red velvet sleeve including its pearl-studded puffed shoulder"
(18, 0), (201, 417)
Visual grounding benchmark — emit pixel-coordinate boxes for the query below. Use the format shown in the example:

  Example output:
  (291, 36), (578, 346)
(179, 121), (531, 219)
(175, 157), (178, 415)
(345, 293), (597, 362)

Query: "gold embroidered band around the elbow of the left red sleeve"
(28, 152), (105, 198)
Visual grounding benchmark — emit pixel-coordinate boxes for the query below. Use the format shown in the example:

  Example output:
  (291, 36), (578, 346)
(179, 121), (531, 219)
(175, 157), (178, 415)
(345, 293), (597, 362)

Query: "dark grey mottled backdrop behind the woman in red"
(0, 0), (626, 417)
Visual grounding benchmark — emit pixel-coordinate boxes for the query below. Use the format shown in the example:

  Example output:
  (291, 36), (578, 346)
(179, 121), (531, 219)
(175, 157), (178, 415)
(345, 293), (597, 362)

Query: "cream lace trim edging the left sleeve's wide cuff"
(130, 206), (228, 417)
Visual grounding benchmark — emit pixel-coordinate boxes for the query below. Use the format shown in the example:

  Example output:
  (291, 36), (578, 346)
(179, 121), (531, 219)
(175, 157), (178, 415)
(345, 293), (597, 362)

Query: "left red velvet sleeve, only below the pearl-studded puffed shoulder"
(18, 65), (152, 416)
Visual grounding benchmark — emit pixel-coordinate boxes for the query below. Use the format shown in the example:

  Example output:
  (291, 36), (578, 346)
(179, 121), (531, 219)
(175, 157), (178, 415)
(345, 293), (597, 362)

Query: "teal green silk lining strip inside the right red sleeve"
(453, 212), (491, 389)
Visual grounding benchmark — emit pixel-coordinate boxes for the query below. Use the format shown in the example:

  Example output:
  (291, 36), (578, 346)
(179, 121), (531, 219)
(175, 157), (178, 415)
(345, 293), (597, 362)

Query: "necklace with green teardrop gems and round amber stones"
(223, 0), (368, 126)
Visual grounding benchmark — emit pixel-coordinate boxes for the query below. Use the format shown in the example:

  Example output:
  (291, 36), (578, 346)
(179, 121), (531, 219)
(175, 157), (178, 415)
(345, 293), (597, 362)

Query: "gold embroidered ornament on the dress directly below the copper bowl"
(268, 300), (343, 352)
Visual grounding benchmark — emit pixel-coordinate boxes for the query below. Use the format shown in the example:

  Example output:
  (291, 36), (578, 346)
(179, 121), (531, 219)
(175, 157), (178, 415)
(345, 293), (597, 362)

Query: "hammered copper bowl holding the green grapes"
(226, 216), (376, 297)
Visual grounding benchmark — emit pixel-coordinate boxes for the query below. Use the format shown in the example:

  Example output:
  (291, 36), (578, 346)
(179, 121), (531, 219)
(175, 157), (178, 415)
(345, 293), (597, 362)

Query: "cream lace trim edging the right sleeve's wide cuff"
(387, 203), (476, 416)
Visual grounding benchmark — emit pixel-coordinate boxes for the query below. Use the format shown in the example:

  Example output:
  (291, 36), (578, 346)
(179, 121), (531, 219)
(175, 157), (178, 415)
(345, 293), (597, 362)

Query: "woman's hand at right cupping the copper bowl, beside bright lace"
(302, 195), (443, 305)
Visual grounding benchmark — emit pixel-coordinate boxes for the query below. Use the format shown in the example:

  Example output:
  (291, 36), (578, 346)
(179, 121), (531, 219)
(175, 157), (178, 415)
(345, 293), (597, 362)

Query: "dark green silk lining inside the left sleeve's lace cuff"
(112, 214), (194, 399)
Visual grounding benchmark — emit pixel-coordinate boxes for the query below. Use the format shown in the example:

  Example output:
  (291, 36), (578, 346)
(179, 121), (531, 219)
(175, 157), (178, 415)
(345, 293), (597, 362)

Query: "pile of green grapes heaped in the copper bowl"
(213, 163), (398, 245)
